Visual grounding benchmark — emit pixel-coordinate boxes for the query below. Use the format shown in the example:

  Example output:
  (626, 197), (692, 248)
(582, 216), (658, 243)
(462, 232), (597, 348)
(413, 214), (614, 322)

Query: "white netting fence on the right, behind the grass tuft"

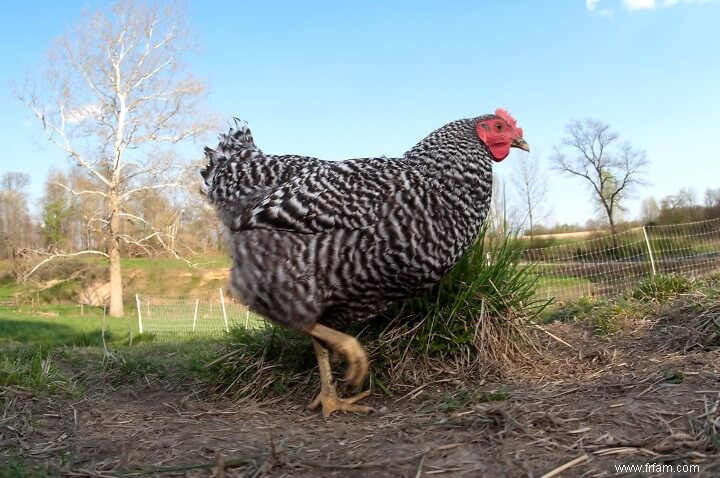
(524, 219), (720, 300)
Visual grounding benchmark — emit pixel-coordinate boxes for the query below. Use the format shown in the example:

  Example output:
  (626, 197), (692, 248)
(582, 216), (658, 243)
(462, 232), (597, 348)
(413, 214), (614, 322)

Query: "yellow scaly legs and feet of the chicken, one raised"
(308, 324), (374, 418)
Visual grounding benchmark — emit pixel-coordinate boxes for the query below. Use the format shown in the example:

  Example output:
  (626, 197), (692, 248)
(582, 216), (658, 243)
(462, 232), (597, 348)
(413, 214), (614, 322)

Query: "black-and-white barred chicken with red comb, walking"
(202, 109), (529, 417)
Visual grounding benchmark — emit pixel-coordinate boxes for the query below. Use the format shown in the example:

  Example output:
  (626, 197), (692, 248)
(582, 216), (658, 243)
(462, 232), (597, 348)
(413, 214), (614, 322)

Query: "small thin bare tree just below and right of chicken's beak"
(512, 154), (547, 243)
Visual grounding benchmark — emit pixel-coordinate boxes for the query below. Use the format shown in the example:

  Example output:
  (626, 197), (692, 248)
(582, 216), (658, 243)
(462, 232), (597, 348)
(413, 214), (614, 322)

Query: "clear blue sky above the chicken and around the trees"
(0, 0), (720, 224)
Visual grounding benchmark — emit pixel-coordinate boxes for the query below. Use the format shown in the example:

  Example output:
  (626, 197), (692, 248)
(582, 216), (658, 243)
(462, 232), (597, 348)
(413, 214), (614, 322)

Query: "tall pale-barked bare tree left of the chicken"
(22, 0), (211, 316)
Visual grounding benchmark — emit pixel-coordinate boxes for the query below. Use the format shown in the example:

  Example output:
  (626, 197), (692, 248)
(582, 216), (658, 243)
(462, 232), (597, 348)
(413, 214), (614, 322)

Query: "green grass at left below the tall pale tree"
(0, 307), (218, 396)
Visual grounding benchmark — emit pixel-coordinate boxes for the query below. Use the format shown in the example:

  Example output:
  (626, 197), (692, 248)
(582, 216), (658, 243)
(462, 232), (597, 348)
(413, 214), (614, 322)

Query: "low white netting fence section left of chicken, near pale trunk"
(135, 289), (264, 339)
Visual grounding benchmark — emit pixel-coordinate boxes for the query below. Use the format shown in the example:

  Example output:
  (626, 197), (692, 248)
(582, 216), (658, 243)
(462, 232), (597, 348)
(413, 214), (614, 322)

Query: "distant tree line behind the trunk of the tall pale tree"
(0, 167), (223, 259)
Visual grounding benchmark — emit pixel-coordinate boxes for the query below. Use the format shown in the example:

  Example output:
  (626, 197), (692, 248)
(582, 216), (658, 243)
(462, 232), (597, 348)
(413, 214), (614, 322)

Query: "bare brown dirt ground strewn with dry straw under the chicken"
(0, 309), (720, 477)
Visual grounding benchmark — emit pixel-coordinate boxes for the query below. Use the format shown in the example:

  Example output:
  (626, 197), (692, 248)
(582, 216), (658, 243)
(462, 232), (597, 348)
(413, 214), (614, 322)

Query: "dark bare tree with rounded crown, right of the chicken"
(552, 119), (648, 234)
